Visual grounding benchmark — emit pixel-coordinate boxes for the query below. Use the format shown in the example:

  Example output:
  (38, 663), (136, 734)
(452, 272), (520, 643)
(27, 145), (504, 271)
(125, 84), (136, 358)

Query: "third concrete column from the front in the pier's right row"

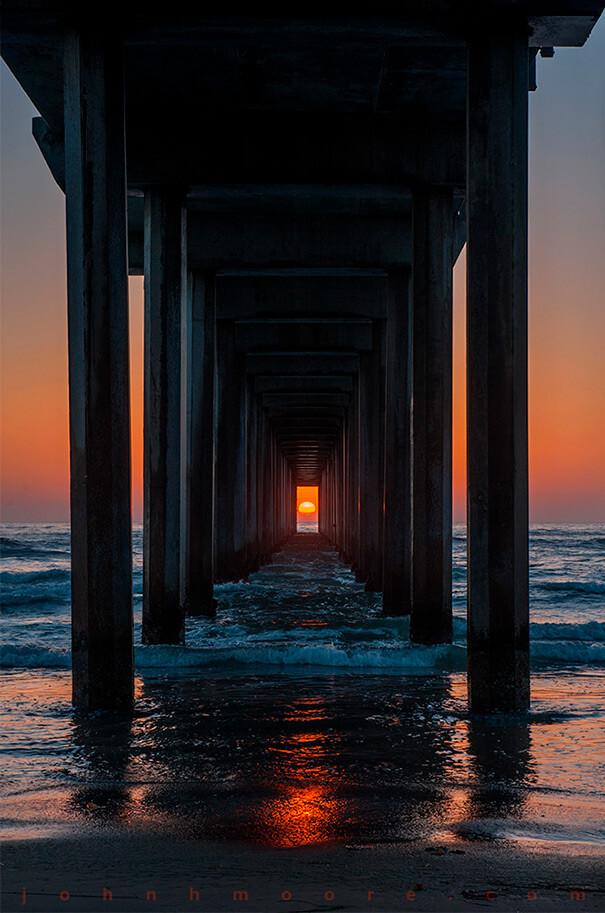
(382, 269), (412, 615)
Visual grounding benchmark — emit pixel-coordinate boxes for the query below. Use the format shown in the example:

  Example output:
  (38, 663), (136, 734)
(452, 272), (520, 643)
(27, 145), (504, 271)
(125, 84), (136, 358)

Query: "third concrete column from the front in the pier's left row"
(181, 271), (216, 616)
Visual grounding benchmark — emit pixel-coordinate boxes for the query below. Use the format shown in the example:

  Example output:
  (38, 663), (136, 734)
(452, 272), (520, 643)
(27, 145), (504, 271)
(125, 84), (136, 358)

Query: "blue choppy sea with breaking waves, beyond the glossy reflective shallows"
(0, 524), (605, 673)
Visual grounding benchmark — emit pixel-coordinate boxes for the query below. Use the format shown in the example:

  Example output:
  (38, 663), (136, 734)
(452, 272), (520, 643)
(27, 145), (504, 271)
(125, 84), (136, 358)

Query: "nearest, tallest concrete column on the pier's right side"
(467, 22), (529, 712)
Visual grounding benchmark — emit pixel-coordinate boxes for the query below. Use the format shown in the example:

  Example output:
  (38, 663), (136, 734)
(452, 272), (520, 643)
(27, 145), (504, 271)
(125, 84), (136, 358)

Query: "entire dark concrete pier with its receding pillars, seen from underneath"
(2, 0), (603, 711)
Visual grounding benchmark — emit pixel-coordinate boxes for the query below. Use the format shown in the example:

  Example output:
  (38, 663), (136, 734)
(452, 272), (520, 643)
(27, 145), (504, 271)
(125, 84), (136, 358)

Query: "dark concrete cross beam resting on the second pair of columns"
(121, 111), (462, 187)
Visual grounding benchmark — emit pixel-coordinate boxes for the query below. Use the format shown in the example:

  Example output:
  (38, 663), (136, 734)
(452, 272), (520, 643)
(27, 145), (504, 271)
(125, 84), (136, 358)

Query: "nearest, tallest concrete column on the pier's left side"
(64, 32), (133, 710)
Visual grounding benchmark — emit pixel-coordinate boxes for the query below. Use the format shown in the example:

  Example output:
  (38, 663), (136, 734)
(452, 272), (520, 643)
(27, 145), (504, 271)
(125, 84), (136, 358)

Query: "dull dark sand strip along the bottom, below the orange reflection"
(2, 828), (605, 913)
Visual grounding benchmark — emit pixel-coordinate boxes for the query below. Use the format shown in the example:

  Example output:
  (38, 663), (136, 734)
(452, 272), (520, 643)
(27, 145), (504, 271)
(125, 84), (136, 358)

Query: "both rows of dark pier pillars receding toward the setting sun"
(65, 31), (529, 710)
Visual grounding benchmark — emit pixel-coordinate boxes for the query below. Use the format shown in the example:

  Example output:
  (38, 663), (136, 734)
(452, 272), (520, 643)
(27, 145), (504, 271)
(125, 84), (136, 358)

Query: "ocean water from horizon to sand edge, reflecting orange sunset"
(1, 524), (605, 854)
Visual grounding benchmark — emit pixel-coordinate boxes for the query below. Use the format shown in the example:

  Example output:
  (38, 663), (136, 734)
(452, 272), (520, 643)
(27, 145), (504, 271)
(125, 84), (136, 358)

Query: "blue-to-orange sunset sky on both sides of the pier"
(0, 17), (605, 522)
